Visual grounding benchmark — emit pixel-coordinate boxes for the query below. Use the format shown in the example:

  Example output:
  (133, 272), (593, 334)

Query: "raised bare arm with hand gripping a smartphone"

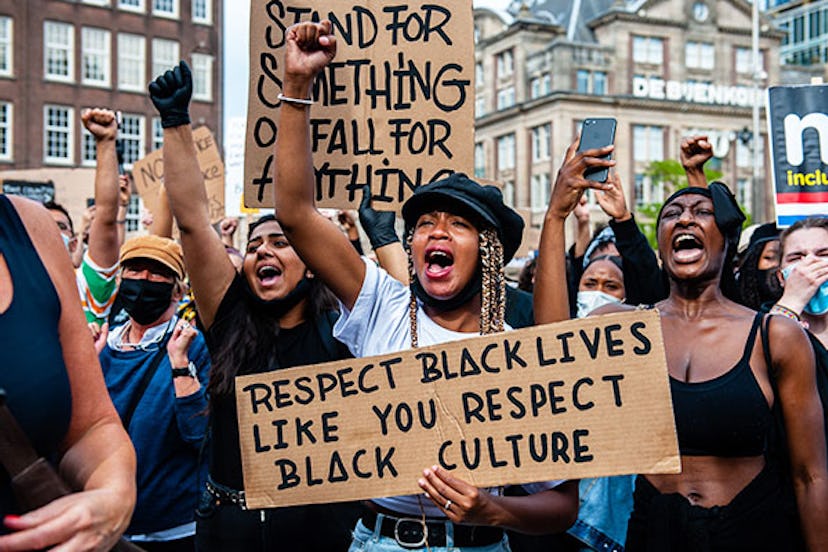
(534, 141), (615, 324)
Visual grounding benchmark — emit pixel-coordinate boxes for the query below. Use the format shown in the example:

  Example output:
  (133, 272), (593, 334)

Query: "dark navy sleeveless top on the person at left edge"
(0, 194), (72, 520)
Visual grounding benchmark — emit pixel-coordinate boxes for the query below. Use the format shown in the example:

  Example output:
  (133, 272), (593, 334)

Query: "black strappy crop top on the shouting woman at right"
(670, 313), (773, 457)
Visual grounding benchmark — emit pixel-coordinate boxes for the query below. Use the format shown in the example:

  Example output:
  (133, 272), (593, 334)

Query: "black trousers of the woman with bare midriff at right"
(625, 467), (802, 552)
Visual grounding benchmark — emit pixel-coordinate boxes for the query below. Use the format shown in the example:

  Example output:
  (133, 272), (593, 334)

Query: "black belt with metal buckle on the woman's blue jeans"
(362, 510), (503, 549)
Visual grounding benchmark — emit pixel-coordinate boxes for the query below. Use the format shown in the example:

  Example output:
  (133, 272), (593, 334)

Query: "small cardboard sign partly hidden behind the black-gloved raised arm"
(132, 126), (224, 224)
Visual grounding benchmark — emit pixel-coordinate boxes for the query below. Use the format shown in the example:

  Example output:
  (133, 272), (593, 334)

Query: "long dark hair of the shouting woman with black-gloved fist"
(207, 215), (337, 398)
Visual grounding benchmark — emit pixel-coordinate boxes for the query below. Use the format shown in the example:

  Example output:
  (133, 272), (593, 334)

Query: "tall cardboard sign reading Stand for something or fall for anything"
(244, 0), (474, 210)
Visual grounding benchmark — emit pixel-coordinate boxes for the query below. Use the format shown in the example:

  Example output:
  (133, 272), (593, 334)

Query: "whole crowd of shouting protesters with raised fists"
(0, 17), (828, 552)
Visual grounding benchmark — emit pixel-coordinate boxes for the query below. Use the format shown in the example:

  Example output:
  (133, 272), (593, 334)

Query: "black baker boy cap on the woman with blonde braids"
(402, 173), (524, 264)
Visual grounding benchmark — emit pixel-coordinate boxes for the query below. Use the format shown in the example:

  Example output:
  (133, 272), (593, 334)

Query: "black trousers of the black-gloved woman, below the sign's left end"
(196, 492), (364, 552)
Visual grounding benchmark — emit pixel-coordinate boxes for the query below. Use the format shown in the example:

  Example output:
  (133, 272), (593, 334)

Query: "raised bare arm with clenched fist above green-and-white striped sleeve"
(81, 108), (121, 267)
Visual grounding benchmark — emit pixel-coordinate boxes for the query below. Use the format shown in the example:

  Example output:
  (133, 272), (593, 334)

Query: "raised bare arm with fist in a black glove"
(149, 61), (236, 328)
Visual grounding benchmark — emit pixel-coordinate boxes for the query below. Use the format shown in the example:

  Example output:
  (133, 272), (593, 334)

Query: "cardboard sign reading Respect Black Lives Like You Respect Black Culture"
(236, 311), (680, 508)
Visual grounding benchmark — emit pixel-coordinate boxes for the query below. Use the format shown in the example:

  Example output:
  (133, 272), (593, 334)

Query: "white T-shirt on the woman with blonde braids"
(333, 258), (563, 518)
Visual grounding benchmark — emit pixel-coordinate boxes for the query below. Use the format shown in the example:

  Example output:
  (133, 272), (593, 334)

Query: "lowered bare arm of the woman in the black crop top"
(769, 316), (828, 550)
